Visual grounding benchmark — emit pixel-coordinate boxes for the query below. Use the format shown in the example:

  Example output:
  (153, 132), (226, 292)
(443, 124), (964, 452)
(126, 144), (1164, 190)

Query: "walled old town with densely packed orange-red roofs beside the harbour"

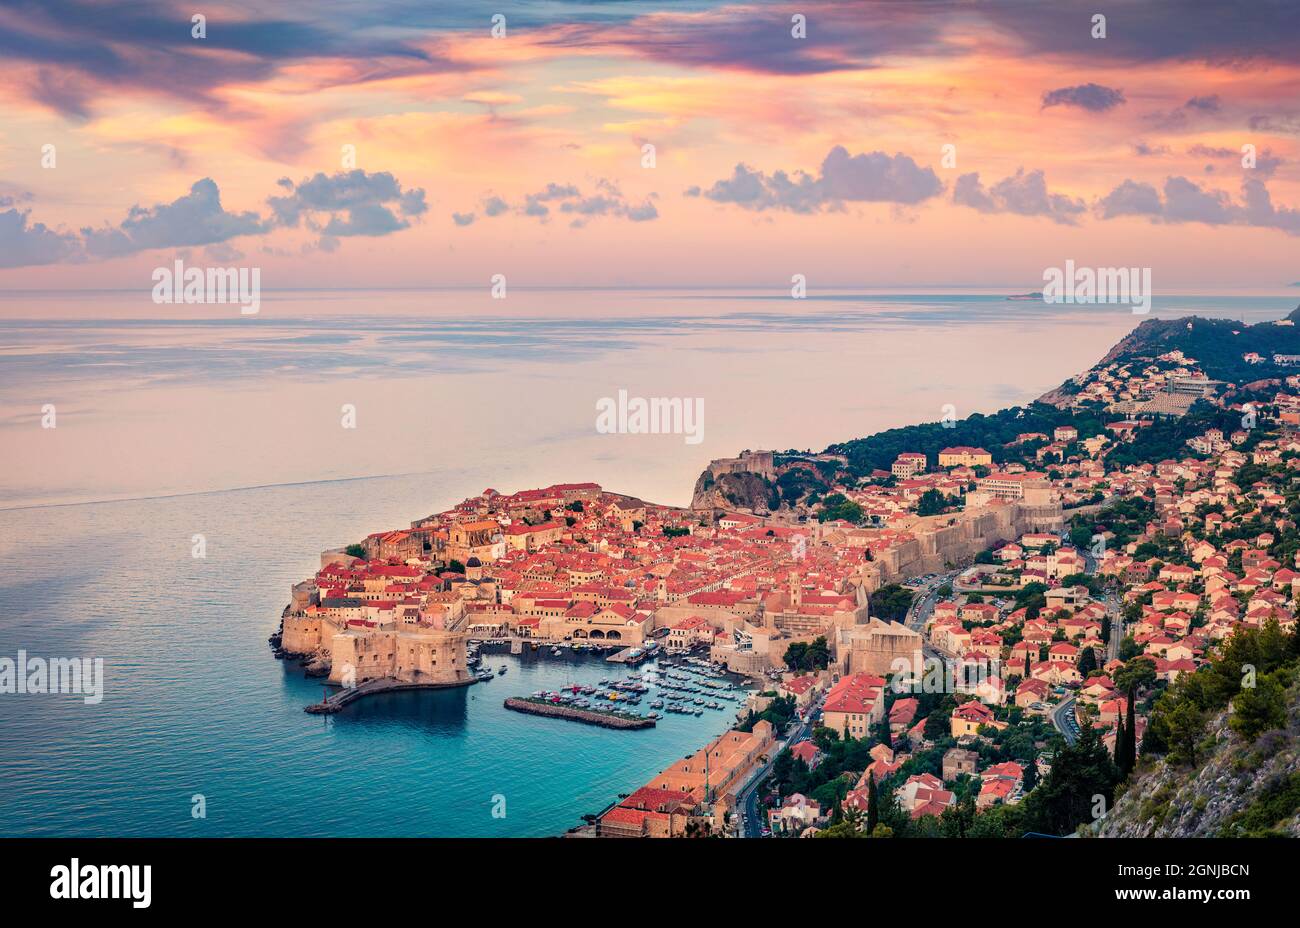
(282, 483), (941, 682)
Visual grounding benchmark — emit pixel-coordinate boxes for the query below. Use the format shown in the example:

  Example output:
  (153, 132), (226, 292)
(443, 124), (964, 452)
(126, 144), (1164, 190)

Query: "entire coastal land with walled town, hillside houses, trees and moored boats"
(272, 309), (1300, 837)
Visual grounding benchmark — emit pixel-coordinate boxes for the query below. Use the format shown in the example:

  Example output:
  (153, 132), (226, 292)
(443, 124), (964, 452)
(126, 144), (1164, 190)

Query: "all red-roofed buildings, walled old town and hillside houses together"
(283, 343), (1300, 837)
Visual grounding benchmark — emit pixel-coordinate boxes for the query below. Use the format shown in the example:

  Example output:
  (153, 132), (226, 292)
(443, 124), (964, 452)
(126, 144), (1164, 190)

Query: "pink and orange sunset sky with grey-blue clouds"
(0, 0), (1300, 292)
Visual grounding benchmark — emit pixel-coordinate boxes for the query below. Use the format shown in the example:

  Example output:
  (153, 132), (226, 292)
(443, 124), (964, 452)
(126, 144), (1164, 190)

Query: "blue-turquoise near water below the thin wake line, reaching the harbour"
(0, 476), (754, 836)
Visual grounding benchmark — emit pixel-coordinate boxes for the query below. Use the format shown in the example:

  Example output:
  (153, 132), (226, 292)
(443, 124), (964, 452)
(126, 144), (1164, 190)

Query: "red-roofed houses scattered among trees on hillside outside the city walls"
(733, 352), (1300, 837)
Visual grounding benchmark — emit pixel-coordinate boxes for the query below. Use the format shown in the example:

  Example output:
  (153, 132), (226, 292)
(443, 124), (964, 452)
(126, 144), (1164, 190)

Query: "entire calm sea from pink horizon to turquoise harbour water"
(0, 292), (1295, 836)
